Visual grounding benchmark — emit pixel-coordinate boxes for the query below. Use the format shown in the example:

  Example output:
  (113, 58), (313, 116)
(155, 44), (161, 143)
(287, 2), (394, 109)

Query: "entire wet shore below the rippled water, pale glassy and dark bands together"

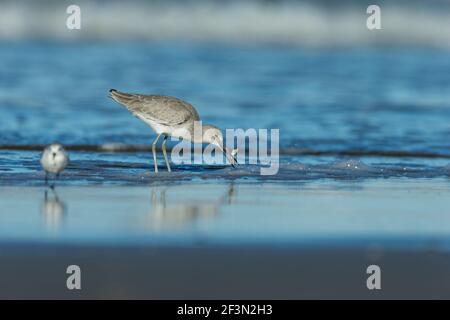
(0, 179), (450, 299)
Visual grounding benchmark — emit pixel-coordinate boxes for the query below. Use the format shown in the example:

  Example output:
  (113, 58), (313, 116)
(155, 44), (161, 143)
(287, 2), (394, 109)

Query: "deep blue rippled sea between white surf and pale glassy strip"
(0, 41), (450, 184)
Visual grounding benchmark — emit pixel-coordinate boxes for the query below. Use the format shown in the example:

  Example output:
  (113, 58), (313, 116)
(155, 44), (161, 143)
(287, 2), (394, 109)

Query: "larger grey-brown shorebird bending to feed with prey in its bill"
(109, 89), (237, 172)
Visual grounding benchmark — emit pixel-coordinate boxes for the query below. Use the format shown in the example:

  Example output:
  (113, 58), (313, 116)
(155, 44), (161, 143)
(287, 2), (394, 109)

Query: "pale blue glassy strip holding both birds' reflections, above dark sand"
(0, 178), (450, 250)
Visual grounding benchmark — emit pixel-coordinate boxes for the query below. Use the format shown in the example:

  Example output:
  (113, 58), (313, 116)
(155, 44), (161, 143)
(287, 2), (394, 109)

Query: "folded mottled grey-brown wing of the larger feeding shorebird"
(111, 91), (200, 126)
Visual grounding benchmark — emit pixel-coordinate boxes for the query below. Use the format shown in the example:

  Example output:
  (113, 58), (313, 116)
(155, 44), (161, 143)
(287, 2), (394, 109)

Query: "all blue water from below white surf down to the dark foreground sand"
(0, 42), (450, 248)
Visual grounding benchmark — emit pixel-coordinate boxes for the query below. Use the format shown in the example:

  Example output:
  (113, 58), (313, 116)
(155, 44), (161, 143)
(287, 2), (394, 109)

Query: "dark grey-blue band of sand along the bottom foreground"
(0, 244), (450, 299)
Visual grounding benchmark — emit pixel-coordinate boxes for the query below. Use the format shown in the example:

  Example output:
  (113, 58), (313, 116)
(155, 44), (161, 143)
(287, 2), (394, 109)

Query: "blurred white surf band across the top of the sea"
(0, 0), (450, 48)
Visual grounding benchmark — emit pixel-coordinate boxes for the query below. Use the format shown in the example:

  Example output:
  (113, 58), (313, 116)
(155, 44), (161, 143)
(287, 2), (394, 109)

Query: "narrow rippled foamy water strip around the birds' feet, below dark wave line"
(0, 151), (450, 186)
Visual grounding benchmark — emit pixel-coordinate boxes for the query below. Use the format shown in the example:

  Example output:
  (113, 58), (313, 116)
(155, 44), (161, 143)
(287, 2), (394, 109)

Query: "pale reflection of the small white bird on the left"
(41, 188), (67, 232)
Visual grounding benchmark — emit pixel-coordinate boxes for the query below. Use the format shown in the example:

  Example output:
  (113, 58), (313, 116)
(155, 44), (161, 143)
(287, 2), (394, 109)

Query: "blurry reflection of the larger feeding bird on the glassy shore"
(144, 184), (236, 231)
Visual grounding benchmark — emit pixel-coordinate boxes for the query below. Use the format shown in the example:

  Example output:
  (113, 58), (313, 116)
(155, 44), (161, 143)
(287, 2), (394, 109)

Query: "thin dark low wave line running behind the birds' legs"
(0, 143), (450, 159)
